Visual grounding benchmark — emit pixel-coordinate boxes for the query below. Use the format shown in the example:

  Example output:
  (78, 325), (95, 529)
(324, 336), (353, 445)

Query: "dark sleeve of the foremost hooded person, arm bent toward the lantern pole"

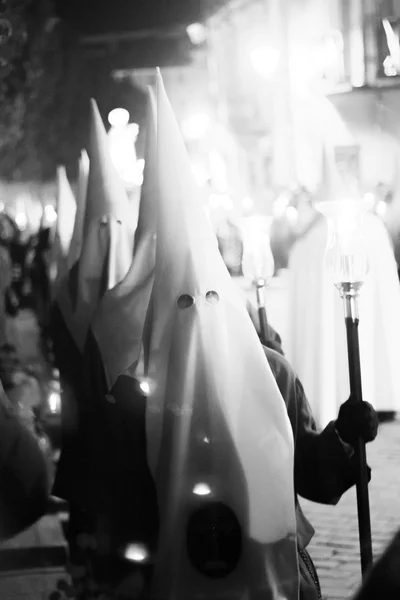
(265, 349), (356, 504)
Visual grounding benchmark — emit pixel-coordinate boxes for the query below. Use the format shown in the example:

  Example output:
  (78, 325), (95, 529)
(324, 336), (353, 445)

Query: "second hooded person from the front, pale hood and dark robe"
(71, 95), (158, 560)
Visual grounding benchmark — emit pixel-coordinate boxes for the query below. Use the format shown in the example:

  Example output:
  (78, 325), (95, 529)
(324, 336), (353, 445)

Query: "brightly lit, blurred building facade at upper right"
(122, 0), (400, 220)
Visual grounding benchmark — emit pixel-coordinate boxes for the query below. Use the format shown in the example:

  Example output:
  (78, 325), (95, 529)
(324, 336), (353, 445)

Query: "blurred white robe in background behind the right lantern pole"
(283, 214), (400, 427)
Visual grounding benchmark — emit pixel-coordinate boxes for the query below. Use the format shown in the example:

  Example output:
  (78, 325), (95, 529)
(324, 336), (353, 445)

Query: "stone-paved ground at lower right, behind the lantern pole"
(301, 420), (400, 600)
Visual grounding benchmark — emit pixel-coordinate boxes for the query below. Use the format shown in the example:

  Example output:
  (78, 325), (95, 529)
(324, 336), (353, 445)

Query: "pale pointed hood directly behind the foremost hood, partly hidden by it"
(92, 89), (157, 389)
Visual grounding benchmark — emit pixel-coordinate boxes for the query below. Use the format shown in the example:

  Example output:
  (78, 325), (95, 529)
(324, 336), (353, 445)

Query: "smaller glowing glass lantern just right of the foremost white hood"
(242, 216), (275, 344)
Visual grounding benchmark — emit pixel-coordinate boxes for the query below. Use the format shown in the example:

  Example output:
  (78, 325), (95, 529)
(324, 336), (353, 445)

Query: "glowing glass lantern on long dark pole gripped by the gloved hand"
(316, 200), (373, 575)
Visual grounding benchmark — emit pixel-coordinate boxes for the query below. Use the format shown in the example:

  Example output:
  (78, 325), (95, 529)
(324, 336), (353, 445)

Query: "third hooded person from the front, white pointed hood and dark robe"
(52, 100), (135, 504)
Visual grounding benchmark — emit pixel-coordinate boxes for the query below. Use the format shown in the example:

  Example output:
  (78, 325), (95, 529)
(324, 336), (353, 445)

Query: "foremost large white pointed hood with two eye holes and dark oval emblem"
(146, 71), (298, 600)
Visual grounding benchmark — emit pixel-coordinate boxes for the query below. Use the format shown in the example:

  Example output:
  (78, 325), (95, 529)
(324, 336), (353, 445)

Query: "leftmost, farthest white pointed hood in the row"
(51, 167), (76, 297)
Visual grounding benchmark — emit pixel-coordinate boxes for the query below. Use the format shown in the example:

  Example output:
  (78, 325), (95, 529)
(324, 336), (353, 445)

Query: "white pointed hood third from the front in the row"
(60, 100), (135, 351)
